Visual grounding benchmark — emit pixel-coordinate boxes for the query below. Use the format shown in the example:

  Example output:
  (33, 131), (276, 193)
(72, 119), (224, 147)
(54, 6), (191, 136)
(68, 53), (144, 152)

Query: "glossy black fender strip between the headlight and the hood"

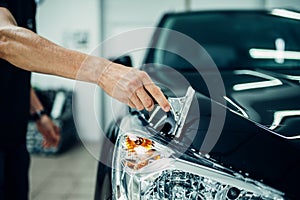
(182, 95), (300, 199)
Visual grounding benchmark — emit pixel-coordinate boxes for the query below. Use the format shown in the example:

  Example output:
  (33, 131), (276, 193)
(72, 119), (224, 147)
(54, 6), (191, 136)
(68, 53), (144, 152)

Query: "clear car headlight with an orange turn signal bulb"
(112, 130), (284, 200)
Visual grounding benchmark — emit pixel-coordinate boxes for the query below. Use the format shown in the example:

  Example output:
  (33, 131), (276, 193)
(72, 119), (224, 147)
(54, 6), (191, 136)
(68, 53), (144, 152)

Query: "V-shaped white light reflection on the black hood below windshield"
(233, 70), (282, 91)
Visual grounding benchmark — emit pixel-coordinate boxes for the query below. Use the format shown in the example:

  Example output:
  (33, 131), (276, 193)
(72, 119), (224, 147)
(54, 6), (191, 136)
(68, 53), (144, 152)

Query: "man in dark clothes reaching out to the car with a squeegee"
(0, 0), (170, 200)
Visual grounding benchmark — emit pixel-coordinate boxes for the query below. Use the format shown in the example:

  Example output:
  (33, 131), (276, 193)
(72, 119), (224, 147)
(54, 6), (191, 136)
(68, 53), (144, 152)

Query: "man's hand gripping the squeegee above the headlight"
(98, 63), (170, 112)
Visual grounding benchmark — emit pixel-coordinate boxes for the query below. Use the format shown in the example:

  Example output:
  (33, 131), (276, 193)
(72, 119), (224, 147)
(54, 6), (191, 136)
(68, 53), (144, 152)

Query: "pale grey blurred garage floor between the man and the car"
(30, 145), (97, 200)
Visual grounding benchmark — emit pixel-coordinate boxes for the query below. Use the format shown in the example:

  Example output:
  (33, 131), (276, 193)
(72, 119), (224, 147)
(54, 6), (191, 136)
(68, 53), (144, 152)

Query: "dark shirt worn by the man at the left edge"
(0, 0), (36, 148)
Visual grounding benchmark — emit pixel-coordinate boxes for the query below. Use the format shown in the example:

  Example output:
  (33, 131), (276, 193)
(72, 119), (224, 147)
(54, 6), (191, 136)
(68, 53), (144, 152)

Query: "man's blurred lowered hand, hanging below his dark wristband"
(36, 115), (60, 148)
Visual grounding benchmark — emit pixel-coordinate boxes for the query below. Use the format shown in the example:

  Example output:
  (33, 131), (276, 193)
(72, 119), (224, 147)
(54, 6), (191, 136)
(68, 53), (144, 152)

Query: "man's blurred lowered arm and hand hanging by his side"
(30, 88), (60, 148)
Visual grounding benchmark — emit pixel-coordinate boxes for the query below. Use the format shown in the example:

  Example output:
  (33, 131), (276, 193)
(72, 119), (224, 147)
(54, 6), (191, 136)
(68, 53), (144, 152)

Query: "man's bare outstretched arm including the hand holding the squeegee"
(0, 7), (170, 111)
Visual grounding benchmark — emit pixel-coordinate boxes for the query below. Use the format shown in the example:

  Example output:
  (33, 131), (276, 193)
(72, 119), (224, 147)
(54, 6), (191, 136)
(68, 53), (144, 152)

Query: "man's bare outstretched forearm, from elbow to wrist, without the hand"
(0, 25), (110, 83)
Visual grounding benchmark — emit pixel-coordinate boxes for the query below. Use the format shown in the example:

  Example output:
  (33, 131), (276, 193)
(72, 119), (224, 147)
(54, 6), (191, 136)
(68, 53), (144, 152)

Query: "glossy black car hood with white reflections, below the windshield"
(147, 68), (300, 137)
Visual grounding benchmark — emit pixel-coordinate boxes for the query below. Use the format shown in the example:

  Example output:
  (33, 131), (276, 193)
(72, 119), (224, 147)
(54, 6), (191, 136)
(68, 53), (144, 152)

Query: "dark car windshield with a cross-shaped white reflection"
(146, 11), (300, 70)
